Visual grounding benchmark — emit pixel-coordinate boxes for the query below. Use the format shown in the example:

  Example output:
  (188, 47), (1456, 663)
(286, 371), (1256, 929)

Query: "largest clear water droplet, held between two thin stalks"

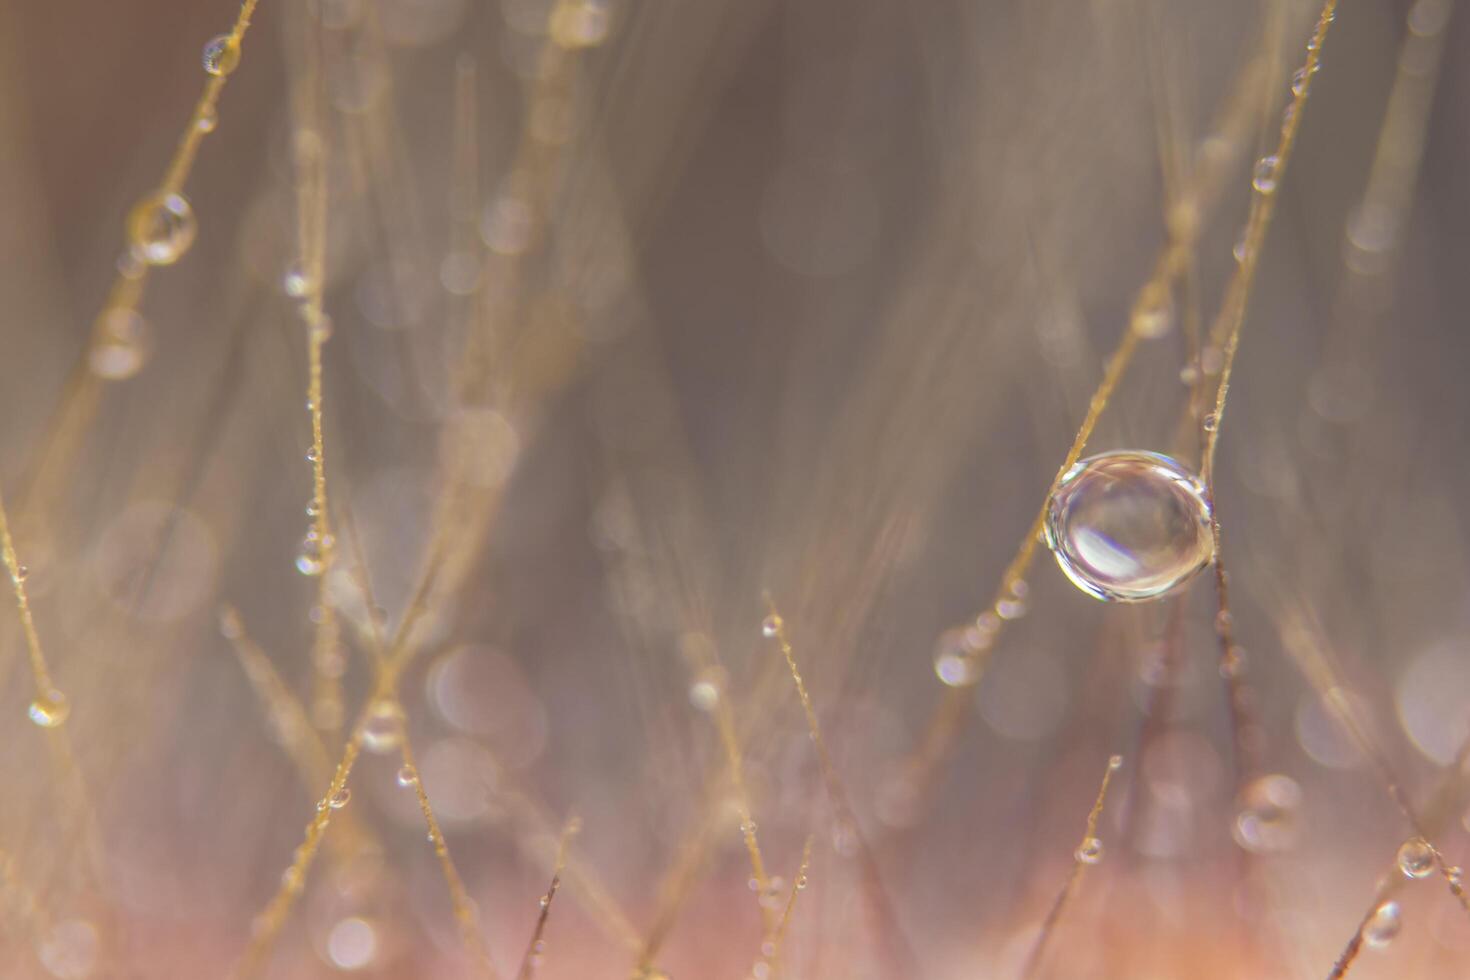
(1045, 450), (1214, 602)
